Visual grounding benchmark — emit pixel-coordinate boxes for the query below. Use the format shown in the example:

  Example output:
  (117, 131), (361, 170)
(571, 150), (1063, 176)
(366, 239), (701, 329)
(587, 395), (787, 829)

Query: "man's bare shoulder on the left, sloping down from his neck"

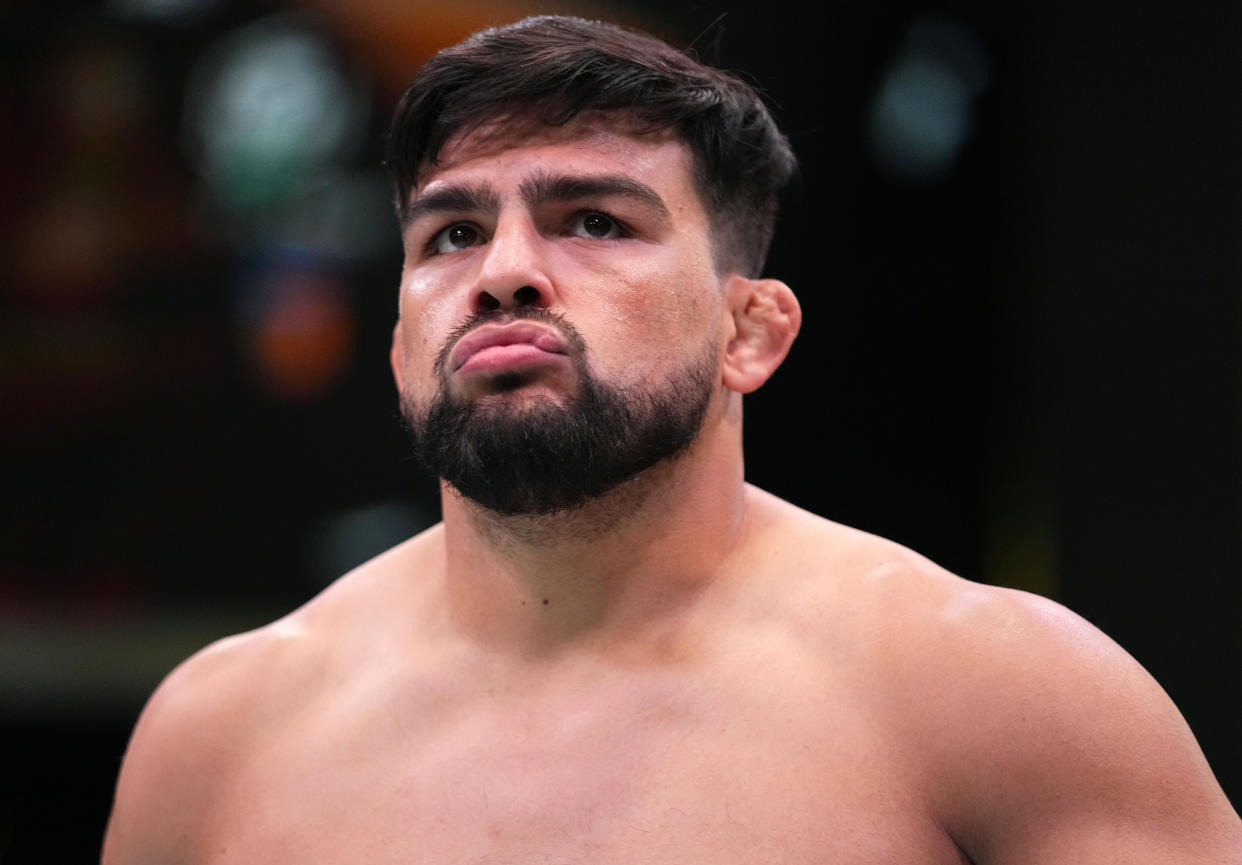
(103, 524), (444, 865)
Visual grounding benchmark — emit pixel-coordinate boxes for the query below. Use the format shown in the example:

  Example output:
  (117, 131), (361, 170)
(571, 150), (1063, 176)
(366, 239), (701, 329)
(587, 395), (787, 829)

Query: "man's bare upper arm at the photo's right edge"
(904, 587), (1242, 865)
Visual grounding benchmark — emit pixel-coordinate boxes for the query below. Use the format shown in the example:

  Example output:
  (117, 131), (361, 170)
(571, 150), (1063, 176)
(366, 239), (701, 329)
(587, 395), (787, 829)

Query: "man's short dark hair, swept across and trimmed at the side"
(385, 16), (797, 276)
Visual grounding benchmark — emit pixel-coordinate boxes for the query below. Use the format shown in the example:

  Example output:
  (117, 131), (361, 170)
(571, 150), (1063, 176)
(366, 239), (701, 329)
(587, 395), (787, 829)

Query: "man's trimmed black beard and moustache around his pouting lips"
(401, 307), (715, 516)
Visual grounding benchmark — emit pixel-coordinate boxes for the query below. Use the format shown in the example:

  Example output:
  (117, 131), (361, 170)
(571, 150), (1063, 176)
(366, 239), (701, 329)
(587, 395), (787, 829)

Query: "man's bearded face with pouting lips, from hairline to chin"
(392, 111), (724, 513)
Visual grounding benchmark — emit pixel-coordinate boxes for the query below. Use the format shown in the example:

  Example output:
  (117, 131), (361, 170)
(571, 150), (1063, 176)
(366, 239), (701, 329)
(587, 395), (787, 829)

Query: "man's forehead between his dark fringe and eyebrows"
(414, 112), (694, 193)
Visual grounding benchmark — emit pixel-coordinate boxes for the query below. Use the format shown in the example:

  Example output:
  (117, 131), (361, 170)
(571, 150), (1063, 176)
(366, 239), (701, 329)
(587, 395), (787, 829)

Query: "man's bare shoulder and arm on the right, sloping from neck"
(745, 492), (1242, 865)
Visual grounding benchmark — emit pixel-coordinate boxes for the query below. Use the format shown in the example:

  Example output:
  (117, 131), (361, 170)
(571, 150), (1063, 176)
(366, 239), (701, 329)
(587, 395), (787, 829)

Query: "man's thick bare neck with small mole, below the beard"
(442, 408), (746, 651)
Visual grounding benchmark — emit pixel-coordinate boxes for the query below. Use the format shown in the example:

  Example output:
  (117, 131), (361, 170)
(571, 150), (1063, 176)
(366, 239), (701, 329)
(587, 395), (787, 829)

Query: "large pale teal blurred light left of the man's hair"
(185, 15), (366, 210)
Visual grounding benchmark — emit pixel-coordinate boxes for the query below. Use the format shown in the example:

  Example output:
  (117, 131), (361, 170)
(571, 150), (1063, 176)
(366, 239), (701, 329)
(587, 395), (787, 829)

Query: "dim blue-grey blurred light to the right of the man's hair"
(869, 19), (987, 179)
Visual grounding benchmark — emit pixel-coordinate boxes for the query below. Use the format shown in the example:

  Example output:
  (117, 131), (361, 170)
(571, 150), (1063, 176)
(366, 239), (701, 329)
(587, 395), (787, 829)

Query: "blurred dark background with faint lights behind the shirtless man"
(0, 0), (1242, 865)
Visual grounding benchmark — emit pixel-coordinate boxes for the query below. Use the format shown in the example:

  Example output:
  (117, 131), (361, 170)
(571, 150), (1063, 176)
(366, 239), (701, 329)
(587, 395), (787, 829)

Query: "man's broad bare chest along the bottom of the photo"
(204, 661), (964, 865)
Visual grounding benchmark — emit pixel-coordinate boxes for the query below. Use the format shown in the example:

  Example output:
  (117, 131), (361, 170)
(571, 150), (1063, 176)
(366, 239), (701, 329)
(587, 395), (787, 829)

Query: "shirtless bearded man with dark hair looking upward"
(103, 19), (1242, 865)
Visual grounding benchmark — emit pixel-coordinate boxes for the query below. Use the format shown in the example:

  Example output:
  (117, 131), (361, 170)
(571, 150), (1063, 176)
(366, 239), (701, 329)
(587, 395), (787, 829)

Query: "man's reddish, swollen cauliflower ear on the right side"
(722, 275), (802, 394)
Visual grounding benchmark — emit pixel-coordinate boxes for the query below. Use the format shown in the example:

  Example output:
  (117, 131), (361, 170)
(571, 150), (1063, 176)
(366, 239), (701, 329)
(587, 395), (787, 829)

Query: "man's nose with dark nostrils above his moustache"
(472, 216), (553, 312)
